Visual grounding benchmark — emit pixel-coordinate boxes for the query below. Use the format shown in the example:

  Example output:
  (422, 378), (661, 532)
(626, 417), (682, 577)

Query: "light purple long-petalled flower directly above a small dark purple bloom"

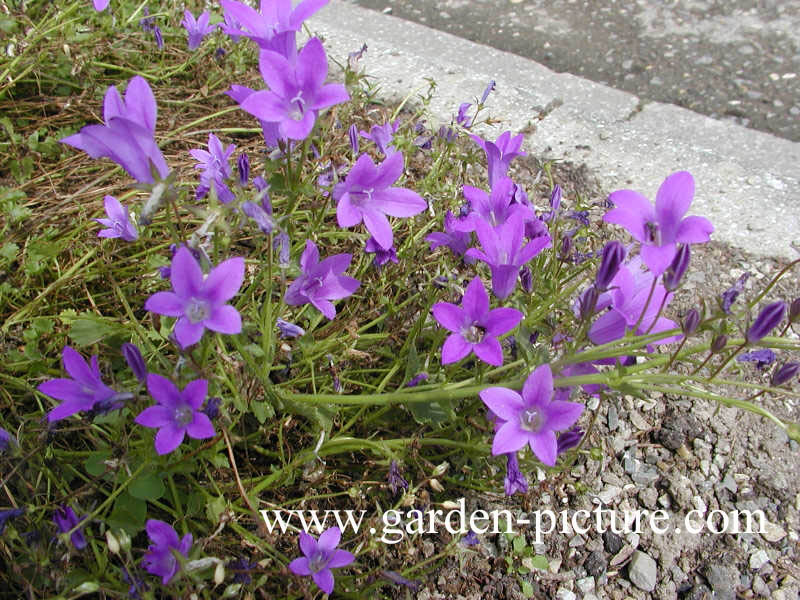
(333, 152), (428, 249)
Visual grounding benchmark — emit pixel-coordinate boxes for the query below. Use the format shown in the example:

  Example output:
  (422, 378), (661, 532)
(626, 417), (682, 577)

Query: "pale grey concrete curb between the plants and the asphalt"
(309, 0), (800, 257)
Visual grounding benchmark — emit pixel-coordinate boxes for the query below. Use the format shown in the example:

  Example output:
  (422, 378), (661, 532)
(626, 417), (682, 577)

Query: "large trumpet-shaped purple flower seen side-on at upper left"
(59, 75), (169, 183)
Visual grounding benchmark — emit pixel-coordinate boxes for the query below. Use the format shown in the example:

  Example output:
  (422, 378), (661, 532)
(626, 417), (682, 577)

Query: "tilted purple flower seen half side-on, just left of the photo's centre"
(284, 240), (361, 319)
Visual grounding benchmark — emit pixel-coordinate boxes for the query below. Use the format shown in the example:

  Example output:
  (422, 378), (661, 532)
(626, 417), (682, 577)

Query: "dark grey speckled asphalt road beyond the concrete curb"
(350, 0), (800, 141)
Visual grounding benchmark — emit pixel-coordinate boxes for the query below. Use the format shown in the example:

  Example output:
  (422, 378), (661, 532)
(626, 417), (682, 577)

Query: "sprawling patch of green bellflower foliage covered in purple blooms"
(0, 0), (800, 598)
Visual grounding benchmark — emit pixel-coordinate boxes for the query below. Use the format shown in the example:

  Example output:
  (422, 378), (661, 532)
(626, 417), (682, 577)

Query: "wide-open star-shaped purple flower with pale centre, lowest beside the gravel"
(480, 364), (583, 467)
